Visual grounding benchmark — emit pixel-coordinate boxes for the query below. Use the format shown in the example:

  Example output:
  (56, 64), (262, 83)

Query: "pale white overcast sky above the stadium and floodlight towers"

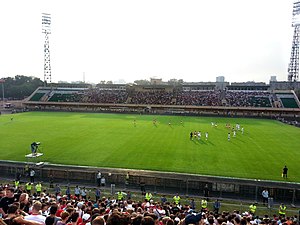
(0, 0), (294, 83)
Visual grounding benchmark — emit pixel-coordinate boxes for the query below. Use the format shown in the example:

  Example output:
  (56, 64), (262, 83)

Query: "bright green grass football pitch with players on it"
(0, 112), (300, 182)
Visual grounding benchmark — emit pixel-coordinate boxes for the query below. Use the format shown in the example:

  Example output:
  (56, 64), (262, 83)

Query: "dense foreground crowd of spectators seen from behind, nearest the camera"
(0, 183), (299, 225)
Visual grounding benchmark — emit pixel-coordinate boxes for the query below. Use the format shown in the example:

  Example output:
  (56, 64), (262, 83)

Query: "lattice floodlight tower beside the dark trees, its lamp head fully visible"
(42, 13), (51, 86)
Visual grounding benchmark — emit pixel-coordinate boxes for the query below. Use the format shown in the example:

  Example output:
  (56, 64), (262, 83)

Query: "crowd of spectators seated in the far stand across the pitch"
(32, 88), (297, 107)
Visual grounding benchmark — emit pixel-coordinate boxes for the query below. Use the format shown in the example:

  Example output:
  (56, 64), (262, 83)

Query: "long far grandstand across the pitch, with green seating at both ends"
(28, 85), (300, 108)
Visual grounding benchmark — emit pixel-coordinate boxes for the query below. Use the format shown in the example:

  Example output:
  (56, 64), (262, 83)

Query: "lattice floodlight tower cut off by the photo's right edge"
(288, 0), (300, 82)
